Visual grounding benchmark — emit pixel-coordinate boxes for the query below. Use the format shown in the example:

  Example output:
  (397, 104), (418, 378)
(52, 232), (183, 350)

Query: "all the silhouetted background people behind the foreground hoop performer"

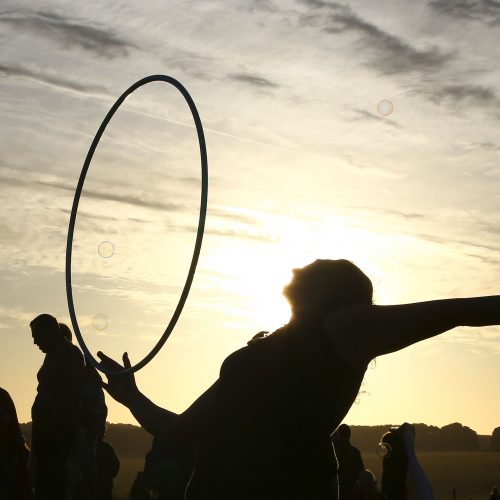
(0, 314), (500, 500)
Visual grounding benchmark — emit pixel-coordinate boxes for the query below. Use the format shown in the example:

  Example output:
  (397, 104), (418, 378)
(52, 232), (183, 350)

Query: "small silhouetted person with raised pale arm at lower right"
(382, 422), (434, 500)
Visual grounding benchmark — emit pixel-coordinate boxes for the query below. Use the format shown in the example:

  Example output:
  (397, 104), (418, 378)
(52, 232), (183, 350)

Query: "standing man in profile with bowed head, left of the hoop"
(30, 314), (84, 500)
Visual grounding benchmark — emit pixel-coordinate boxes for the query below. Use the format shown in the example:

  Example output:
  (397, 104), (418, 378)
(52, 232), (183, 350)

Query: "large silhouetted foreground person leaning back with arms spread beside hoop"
(98, 260), (500, 500)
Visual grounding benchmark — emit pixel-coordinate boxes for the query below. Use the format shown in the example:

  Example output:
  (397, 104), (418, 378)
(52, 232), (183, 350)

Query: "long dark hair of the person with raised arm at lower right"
(381, 427), (408, 499)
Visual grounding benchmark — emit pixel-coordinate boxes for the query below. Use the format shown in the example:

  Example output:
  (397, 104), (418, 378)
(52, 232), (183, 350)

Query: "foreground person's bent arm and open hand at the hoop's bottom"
(97, 352), (218, 439)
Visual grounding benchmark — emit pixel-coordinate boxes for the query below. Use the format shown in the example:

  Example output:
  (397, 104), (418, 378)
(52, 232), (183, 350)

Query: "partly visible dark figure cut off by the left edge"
(0, 387), (32, 500)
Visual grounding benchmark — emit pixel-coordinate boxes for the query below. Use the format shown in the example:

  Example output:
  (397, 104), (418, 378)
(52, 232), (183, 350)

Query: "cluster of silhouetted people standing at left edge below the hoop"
(0, 314), (120, 500)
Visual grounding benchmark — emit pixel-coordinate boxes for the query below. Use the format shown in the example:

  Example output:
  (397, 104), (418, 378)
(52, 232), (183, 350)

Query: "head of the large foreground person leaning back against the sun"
(283, 259), (373, 317)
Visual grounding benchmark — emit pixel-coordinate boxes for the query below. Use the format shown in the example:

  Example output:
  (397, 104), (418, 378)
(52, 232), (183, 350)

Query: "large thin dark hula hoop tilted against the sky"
(66, 75), (208, 375)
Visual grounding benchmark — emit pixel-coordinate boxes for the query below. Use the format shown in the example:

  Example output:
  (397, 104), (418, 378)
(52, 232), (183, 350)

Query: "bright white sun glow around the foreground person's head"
(205, 209), (386, 334)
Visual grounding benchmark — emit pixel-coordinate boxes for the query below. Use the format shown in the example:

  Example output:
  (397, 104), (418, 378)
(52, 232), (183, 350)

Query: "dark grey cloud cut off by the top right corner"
(429, 0), (500, 26)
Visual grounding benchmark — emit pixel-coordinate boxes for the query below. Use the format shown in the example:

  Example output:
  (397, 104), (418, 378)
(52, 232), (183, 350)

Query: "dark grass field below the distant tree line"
(113, 452), (500, 500)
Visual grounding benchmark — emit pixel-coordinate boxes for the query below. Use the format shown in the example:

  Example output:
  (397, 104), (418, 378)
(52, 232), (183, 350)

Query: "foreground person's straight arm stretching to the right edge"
(324, 295), (500, 363)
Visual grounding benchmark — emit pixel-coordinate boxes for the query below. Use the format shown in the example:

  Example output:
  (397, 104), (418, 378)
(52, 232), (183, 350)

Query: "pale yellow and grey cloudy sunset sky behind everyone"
(0, 0), (500, 434)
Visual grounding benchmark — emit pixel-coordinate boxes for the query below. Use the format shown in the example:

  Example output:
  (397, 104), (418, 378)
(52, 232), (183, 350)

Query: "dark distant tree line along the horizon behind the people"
(21, 422), (492, 458)
